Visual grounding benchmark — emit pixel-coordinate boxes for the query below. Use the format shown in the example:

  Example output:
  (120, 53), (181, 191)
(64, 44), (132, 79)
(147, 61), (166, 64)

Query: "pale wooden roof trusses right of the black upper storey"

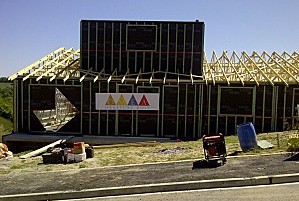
(203, 51), (299, 86)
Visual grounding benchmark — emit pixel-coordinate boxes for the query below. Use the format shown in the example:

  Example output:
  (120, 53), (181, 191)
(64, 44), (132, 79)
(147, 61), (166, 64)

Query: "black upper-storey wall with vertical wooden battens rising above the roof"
(80, 20), (204, 75)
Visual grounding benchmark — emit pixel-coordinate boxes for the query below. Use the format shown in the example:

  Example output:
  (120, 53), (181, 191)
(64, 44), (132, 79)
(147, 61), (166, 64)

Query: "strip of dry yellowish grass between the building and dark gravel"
(0, 131), (299, 174)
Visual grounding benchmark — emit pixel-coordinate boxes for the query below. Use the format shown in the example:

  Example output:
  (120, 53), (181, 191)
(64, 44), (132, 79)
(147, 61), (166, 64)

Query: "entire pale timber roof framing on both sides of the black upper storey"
(9, 47), (299, 86)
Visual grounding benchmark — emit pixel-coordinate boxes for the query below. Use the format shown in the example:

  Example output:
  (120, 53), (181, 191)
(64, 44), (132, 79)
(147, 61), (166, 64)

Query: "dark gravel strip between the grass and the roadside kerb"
(0, 154), (299, 195)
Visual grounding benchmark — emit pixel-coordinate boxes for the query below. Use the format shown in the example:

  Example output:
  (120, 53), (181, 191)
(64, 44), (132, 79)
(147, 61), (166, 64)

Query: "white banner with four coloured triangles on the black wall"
(96, 93), (159, 110)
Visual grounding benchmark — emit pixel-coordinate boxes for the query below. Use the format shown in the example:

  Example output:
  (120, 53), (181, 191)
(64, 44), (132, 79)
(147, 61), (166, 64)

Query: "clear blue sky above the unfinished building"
(0, 0), (299, 77)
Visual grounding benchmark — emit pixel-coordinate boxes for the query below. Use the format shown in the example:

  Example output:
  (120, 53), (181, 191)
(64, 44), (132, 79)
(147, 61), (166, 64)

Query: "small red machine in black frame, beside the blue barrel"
(202, 133), (226, 165)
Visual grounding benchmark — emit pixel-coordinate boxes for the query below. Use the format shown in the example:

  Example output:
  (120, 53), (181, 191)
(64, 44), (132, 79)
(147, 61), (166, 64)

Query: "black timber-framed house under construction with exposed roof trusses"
(5, 20), (299, 143)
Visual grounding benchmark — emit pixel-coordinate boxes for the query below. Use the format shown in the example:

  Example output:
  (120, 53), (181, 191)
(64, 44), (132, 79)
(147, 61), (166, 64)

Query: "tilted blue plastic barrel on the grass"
(237, 122), (257, 152)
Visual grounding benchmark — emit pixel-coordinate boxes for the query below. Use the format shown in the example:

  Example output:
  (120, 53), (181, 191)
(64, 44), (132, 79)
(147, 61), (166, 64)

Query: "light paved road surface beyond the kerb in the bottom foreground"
(65, 182), (299, 201)
